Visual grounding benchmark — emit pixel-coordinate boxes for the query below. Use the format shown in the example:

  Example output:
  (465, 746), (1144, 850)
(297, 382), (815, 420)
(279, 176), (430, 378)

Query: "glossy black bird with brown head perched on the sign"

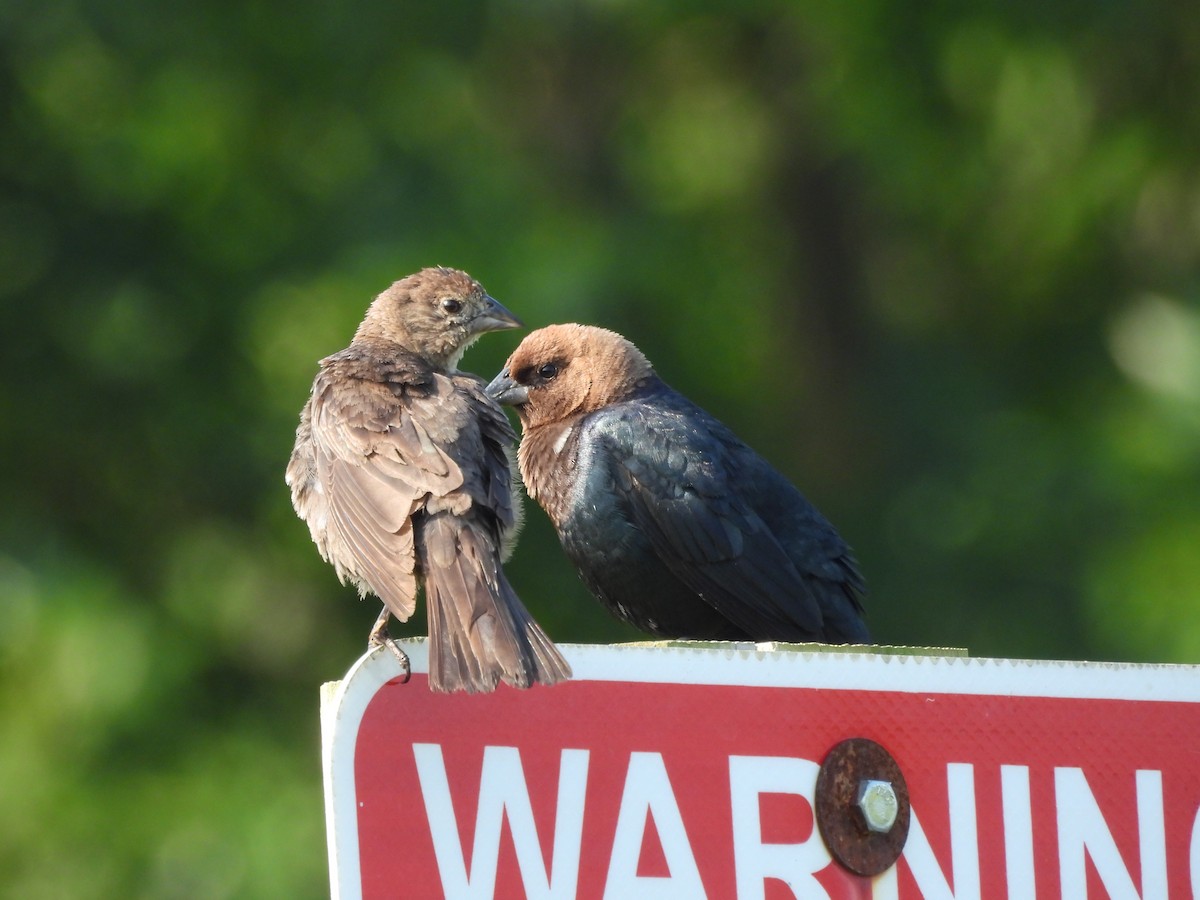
(487, 324), (870, 643)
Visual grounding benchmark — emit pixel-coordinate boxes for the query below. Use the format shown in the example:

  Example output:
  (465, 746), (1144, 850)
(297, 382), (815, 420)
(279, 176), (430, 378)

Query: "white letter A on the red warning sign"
(604, 752), (706, 900)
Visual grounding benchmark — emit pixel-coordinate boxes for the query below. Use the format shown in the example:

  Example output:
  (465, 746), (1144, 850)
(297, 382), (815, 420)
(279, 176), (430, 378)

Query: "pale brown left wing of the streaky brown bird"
(304, 372), (463, 620)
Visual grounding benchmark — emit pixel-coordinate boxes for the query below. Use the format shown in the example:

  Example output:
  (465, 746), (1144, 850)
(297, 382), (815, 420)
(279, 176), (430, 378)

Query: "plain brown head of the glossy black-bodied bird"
(487, 325), (654, 430)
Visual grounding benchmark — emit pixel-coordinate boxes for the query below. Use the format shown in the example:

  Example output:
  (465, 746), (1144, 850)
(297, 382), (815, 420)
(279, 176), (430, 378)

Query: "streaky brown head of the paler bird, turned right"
(354, 266), (521, 371)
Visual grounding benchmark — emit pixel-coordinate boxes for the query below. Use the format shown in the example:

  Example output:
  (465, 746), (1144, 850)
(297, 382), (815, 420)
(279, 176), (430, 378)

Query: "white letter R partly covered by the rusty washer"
(730, 756), (830, 900)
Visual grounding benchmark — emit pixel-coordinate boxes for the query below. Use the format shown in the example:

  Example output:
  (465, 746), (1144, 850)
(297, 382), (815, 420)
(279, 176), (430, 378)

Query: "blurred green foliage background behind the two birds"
(0, 0), (1200, 899)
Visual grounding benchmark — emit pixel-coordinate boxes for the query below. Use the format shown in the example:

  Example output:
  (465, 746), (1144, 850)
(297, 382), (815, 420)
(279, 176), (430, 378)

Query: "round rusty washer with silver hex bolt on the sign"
(815, 738), (908, 877)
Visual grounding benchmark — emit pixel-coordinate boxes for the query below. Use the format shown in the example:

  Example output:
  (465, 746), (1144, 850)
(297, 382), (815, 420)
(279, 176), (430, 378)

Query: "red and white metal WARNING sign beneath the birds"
(323, 641), (1200, 900)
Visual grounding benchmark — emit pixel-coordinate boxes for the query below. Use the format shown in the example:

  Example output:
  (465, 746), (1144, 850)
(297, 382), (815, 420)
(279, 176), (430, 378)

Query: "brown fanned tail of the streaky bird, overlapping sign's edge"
(419, 514), (571, 692)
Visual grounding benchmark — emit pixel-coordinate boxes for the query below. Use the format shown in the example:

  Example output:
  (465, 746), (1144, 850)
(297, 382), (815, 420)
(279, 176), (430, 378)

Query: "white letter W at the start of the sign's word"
(413, 744), (588, 900)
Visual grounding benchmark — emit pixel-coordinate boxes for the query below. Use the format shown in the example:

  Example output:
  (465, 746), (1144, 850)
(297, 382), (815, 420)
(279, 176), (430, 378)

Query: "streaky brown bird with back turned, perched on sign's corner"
(287, 268), (570, 691)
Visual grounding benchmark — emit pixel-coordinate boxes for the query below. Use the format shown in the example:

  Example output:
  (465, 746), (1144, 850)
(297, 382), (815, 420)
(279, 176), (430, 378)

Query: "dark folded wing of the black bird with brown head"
(600, 403), (822, 640)
